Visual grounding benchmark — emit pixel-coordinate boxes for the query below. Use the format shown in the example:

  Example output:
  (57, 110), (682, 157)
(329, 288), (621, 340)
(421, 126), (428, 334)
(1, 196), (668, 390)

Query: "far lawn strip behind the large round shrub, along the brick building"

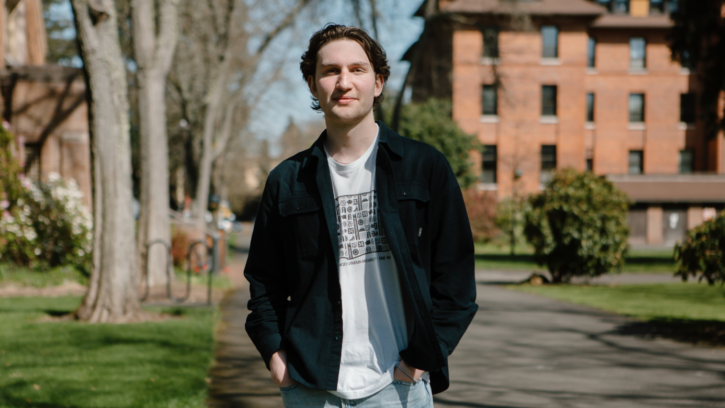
(476, 244), (675, 273)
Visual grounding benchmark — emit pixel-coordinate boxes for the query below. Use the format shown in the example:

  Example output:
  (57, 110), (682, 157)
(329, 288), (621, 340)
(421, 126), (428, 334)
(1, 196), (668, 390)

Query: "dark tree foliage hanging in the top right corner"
(670, 0), (725, 137)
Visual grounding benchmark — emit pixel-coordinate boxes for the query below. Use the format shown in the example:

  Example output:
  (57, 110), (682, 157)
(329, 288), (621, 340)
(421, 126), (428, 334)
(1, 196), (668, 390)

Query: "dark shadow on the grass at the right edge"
(614, 319), (725, 346)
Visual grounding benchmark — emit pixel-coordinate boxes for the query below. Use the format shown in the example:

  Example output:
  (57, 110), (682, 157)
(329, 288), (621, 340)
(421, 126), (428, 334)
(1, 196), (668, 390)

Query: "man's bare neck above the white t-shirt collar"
(325, 112), (378, 164)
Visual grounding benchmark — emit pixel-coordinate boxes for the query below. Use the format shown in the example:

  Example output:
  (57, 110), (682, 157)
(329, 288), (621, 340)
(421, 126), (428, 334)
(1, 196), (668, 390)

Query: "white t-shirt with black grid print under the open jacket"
(325, 128), (408, 399)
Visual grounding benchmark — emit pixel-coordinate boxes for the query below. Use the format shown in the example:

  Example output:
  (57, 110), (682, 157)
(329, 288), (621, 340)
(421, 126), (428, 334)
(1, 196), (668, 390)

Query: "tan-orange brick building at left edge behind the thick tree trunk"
(0, 0), (91, 208)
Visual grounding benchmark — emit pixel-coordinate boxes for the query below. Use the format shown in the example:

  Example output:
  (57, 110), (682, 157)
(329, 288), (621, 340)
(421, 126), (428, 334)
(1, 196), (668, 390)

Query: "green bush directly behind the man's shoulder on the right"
(398, 99), (480, 189)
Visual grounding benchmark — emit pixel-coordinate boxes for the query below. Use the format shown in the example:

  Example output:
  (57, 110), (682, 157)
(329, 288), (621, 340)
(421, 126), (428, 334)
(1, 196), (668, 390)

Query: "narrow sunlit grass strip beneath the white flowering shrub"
(0, 263), (88, 288)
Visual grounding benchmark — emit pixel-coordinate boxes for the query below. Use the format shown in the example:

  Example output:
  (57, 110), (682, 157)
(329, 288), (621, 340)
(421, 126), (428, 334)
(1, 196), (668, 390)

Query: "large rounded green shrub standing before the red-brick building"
(524, 169), (629, 283)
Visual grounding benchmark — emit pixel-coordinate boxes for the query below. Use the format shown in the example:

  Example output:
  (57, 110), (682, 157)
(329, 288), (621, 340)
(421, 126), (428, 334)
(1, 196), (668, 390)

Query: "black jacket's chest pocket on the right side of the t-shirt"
(396, 183), (430, 245)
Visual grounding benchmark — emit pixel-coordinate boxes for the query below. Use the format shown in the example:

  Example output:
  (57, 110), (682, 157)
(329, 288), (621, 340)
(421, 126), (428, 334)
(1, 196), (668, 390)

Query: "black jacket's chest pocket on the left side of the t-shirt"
(279, 196), (324, 257)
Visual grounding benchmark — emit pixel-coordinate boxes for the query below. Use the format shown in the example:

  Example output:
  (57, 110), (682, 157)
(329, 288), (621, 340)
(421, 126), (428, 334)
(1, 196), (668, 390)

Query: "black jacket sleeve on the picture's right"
(430, 154), (478, 358)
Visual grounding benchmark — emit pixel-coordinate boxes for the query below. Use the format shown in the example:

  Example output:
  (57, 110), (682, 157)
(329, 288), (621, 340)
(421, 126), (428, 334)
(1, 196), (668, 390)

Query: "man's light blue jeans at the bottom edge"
(280, 380), (433, 408)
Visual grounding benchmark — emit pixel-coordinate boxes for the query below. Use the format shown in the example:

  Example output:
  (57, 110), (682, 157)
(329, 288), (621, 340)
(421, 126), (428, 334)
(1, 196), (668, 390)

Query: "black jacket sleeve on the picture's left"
(244, 179), (289, 368)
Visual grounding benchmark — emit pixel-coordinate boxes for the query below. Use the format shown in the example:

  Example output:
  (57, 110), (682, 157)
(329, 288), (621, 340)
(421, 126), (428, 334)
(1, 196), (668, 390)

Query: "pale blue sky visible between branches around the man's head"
(43, 0), (423, 146)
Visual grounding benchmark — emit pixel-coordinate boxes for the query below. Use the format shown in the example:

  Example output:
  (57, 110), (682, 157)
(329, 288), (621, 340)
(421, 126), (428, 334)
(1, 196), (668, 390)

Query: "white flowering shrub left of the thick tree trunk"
(0, 173), (93, 267)
